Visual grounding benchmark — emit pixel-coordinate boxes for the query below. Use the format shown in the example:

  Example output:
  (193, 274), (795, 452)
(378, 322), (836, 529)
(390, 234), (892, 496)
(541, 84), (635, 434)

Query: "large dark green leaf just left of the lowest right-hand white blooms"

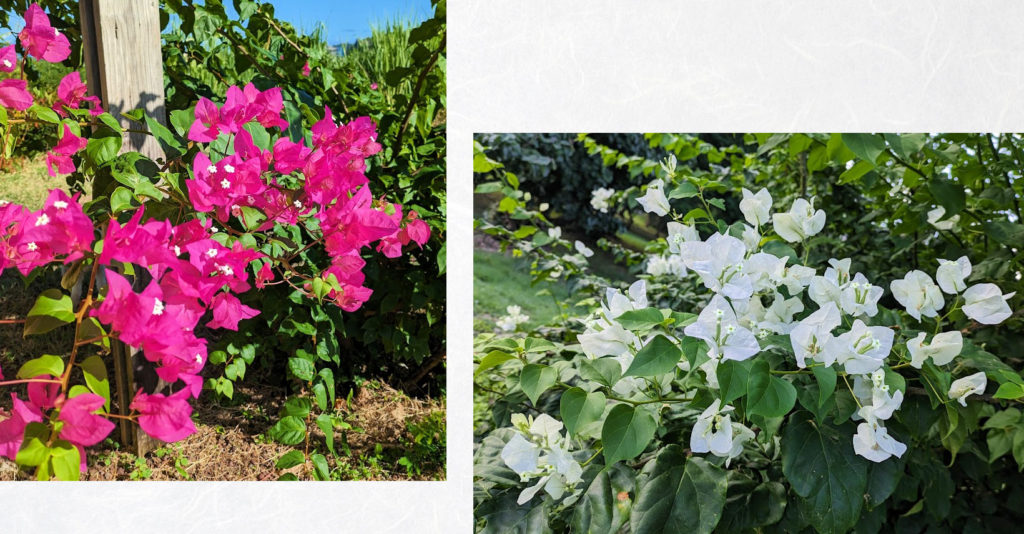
(782, 411), (867, 533)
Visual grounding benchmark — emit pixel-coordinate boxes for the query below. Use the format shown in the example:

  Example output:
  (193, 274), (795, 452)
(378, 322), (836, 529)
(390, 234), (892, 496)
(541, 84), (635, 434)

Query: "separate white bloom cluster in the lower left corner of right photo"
(502, 413), (583, 504)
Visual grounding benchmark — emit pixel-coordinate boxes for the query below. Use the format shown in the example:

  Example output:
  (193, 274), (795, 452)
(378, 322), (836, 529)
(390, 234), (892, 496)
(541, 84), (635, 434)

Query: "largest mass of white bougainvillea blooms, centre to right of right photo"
(598, 187), (1013, 461)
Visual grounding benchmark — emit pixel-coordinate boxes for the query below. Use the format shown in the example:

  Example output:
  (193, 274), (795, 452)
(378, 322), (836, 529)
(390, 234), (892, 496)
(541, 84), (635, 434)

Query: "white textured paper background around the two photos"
(0, 0), (1024, 534)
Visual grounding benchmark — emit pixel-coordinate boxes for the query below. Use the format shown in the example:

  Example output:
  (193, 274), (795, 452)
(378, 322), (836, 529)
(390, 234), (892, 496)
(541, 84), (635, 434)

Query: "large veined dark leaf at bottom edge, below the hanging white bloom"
(631, 445), (728, 534)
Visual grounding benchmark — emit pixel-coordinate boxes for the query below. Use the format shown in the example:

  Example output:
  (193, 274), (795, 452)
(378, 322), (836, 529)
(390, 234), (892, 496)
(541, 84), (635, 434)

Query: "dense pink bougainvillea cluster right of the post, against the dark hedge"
(185, 91), (430, 312)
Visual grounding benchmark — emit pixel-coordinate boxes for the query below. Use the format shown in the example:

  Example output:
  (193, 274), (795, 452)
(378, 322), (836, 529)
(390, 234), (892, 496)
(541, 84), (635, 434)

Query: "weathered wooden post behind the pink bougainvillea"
(79, 0), (166, 455)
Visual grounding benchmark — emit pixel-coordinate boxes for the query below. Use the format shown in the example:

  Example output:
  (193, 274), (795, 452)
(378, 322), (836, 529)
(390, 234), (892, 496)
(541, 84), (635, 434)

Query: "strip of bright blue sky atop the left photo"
(224, 0), (433, 44)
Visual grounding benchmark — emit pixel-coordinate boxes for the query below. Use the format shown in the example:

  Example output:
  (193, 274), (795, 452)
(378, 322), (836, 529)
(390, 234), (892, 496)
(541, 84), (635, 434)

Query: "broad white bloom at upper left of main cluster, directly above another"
(679, 234), (754, 299)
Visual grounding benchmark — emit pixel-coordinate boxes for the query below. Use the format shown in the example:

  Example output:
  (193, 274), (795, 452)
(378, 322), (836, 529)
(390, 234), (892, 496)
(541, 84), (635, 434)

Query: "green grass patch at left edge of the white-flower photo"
(473, 250), (569, 331)
